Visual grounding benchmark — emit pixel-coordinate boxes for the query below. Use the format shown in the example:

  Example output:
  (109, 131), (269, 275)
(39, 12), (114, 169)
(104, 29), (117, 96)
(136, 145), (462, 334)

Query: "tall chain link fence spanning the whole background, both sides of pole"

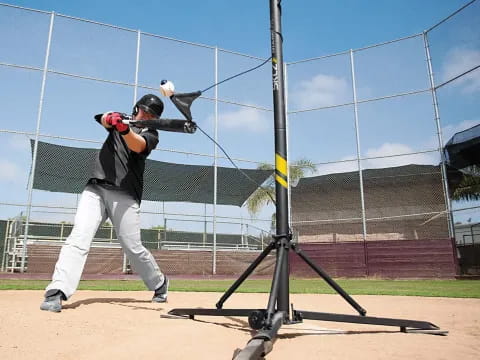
(0, 1), (480, 277)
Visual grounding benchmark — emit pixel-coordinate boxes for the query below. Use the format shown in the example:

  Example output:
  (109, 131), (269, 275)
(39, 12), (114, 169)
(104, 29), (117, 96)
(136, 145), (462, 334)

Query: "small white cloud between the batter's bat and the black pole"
(218, 108), (272, 133)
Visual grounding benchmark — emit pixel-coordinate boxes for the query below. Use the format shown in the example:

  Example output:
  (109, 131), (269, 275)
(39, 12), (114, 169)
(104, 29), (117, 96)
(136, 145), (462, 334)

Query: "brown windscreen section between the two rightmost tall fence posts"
(363, 165), (449, 240)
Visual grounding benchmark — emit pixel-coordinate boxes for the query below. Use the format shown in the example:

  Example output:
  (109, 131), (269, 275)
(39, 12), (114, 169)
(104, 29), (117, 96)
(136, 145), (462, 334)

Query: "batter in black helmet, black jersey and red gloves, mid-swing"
(40, 94), (169, 312)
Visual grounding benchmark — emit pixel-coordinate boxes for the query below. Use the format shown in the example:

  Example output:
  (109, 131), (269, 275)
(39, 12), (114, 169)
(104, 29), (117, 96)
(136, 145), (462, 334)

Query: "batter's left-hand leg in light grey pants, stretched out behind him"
(42, 185), (106, 311)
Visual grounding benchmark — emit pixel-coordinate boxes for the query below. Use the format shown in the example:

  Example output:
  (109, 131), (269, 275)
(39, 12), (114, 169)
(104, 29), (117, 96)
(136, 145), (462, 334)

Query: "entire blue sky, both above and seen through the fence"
(0, 0), (480, 231)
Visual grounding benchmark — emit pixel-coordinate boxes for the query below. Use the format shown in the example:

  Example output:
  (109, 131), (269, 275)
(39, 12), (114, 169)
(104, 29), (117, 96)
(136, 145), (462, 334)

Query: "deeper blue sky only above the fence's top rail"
(0, 0), (467, 61)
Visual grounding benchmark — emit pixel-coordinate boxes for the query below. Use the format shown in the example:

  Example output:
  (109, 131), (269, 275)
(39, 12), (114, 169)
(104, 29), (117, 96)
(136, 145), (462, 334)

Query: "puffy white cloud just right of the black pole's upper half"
(290, 74), (351, 109)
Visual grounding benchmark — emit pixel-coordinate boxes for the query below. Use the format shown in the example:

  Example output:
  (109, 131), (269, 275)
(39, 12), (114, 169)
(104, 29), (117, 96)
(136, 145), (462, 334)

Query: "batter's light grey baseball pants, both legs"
(46, 184), (164, 299)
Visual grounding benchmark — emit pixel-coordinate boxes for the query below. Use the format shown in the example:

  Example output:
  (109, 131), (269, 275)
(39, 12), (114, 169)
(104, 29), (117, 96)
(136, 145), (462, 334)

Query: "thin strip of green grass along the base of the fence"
(0, 279), (480, 298)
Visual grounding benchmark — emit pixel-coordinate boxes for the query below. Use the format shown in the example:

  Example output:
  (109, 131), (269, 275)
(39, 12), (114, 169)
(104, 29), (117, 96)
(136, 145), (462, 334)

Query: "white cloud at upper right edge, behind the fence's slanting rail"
(441, 48), (480, 93)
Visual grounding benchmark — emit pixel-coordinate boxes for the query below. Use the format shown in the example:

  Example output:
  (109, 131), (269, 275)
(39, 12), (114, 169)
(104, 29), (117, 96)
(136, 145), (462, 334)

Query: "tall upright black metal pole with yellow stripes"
(270, 0), (290, 318)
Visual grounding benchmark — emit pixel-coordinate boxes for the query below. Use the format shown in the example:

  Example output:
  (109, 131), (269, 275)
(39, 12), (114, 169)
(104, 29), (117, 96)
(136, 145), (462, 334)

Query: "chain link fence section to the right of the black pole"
(287, 1), (480, 277)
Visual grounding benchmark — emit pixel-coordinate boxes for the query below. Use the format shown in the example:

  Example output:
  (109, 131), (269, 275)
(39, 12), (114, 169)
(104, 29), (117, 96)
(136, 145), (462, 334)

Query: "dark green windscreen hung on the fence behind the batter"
(31, 140), (272, 206)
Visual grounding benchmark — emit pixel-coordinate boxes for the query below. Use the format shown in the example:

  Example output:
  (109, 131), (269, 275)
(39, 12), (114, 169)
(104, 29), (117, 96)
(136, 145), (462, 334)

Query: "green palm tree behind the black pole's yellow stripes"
(247, 159), (317, 219)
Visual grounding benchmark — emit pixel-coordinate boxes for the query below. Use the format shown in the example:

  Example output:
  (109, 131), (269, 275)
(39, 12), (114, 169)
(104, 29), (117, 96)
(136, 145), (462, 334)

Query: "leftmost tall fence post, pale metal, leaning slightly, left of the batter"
(20, 11), (55, 272)
